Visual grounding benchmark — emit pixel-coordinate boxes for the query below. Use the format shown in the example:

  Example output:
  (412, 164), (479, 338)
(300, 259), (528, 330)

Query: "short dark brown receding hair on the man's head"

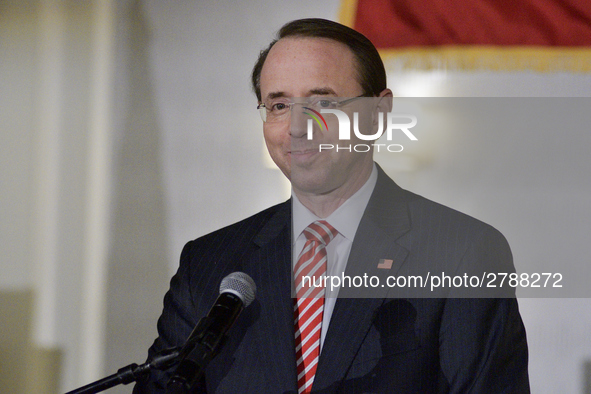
(251, 18), (386, 102)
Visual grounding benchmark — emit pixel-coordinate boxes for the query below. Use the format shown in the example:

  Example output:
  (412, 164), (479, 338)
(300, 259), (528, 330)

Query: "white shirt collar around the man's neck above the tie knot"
(292, 163), (378, 244)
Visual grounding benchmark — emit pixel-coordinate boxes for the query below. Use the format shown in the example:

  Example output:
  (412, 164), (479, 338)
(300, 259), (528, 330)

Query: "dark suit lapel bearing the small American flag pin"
(313, 167), (410, 391)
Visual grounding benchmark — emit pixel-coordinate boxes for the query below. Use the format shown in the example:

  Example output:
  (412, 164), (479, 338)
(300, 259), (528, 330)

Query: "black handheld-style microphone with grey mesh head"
(166, 272), (256, 393)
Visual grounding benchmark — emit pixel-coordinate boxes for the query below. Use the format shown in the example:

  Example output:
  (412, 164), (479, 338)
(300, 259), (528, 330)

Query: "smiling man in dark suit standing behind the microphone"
(135, 19), (529, 393)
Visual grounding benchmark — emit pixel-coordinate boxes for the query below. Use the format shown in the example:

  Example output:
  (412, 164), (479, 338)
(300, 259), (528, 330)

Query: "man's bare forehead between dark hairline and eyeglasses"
(261, 37), (361, 100)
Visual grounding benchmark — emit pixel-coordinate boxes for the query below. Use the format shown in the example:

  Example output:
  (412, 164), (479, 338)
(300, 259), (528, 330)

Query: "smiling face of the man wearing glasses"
(260, 37), (373, 195)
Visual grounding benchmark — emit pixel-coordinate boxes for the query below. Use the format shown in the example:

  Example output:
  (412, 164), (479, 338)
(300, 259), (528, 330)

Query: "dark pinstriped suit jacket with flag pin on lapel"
(134, 165), (529, 393)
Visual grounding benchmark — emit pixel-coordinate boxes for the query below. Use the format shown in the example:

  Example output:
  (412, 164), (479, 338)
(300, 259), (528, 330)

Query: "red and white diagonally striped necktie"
(294, 220), (338, 394)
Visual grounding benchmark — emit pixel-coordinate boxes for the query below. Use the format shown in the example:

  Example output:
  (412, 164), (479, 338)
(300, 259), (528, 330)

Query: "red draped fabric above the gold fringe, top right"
(353, 0), (591, 49)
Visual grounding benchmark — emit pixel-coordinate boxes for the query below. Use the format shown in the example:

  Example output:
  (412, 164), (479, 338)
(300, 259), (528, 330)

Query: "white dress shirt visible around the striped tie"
(292, 163), (378, 349)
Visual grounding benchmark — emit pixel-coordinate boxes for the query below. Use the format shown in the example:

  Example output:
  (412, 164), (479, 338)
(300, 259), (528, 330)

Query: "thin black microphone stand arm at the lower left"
(66, 347), (181, 394)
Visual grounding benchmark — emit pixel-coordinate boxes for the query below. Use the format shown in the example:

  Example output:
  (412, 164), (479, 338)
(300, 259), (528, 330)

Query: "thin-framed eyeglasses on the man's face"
(257, 94), (364, 123)
